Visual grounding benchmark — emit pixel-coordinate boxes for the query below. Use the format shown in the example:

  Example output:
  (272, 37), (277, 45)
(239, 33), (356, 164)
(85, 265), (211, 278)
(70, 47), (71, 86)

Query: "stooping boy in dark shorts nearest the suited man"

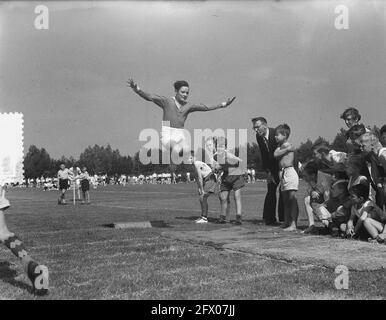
(216, 137), (245, 225)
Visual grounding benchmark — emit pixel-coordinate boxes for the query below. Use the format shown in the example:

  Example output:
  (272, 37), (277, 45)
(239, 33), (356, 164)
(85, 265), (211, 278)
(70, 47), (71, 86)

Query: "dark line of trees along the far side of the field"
(24, 126), (379, 179)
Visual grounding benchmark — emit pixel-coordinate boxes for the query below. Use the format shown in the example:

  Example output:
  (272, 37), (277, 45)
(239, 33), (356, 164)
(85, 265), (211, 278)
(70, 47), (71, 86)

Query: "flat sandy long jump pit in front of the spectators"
(162, 226), (386, 271)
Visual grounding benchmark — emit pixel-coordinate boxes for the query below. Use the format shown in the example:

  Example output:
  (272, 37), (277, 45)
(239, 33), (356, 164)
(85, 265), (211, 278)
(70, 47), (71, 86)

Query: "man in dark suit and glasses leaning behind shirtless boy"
(252, 117), (284, 225)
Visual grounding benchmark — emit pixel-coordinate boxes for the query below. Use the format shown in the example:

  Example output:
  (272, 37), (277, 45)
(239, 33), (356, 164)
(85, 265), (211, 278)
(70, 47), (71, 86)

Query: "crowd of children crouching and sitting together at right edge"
(301, 108), (386, 243)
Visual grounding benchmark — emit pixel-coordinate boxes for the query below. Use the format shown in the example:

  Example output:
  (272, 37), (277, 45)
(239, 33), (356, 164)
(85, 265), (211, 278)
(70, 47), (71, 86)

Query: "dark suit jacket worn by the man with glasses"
(256, 128), (279, 179)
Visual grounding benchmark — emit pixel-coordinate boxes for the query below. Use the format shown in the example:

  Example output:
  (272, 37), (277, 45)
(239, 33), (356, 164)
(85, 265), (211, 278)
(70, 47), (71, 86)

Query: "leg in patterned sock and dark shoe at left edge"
(0, 185), (48, 295)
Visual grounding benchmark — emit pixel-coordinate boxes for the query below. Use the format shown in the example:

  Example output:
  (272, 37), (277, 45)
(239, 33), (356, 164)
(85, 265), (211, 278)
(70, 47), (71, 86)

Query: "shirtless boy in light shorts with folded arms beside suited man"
(273, 123), (299, 231)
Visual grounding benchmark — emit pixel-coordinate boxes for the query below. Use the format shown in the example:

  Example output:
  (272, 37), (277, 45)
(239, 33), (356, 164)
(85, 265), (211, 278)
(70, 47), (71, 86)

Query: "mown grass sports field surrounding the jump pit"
(0, 183), (386, 300)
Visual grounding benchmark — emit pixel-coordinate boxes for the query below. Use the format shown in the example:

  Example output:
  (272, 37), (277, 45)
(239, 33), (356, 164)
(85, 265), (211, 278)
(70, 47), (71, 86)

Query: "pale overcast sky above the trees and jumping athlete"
(0, 0), (386, 158)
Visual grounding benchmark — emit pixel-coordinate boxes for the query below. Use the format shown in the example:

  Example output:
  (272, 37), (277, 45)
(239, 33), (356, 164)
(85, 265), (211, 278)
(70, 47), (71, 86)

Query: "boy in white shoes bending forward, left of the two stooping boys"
(190, 151), (217, 224)
